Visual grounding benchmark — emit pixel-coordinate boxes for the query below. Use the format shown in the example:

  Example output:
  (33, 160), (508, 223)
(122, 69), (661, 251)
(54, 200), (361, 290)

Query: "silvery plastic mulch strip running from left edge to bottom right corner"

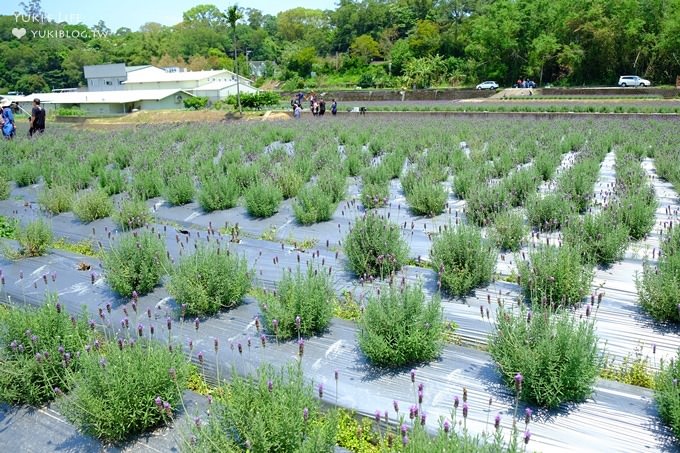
(2, 254), (672, 452)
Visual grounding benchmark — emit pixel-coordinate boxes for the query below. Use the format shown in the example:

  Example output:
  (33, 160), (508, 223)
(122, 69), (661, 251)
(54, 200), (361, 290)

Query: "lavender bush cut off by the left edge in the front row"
(0, 295), (92, 406)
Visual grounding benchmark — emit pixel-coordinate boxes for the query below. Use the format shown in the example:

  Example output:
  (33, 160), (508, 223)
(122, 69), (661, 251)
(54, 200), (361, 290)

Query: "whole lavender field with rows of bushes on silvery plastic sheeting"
(0, 115), (680, 452)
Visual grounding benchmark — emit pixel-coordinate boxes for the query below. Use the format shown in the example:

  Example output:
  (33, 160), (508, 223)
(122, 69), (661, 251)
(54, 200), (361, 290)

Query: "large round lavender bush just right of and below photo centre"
(345, 214), (408, 277)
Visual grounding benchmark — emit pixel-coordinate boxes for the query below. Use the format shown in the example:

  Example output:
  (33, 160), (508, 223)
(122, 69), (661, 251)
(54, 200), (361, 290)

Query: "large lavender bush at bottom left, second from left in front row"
(59, 339), (188, 443)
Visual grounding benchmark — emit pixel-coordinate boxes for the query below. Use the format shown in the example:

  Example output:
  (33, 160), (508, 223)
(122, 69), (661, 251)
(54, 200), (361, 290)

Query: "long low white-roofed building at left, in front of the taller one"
(11, 88), (193, 116)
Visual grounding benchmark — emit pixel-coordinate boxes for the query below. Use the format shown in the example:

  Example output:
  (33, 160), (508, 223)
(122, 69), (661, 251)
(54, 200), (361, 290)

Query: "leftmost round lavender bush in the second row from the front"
(102, 231), (167, 297)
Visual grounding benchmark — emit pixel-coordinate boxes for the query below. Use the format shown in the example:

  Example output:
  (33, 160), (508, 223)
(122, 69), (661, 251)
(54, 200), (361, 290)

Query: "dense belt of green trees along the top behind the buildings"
(0, 0), (680, 90)
